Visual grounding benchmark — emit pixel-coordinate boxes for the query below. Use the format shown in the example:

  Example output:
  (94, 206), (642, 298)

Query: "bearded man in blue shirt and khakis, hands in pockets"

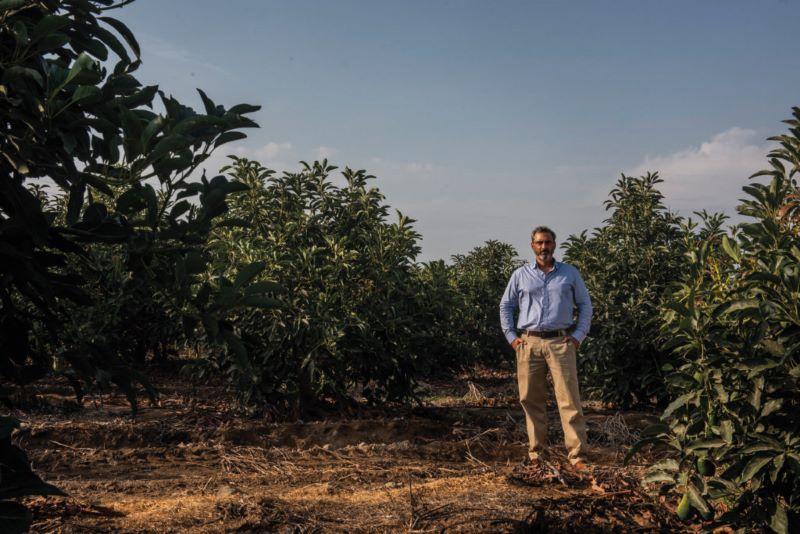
(500, 226), (592, 470)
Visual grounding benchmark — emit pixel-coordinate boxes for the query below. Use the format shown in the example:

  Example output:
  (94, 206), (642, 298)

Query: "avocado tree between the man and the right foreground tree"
(565, 173), (684, 408)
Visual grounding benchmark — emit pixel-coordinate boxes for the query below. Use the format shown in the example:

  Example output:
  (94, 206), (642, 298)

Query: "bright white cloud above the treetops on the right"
(626, 127), (769, 215)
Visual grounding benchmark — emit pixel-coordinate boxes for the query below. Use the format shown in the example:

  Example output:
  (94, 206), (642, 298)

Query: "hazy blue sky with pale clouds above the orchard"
(110, 0), (800, 261)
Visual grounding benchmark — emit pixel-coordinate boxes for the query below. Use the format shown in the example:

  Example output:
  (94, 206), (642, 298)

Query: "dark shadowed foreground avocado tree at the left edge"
(0, 0), (272, 526)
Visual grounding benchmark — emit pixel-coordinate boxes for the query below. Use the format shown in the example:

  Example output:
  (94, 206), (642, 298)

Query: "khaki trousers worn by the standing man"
(516, 334), (588, 463)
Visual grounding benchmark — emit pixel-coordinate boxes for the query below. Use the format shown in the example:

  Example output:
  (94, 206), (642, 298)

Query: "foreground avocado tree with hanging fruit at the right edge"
(638, 108), (800, 532)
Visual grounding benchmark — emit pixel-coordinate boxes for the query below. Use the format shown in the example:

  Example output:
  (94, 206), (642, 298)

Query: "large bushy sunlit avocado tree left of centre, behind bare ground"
(208, 157), (420, 415)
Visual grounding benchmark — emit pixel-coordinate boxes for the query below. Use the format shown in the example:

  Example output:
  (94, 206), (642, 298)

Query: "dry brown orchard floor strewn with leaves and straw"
(7, 371), (689, 532)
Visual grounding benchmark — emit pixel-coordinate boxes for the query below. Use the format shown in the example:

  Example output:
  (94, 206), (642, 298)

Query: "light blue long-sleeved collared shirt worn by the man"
(500, 261), (592, 343)
